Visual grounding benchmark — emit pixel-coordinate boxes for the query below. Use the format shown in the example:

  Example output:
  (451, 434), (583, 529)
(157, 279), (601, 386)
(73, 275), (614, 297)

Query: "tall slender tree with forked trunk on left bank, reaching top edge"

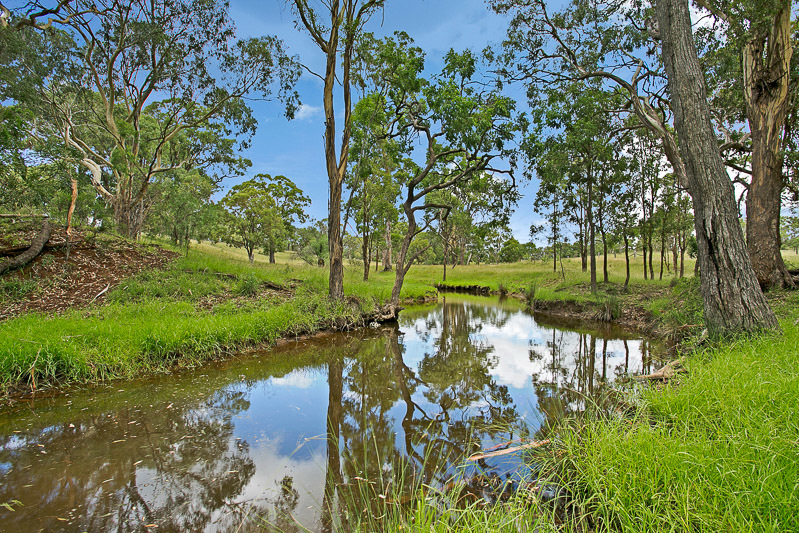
(287, 0), (385, 300)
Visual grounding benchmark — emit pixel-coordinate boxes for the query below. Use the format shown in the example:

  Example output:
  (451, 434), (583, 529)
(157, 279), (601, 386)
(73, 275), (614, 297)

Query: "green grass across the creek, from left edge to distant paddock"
(0, 235), (744, 391)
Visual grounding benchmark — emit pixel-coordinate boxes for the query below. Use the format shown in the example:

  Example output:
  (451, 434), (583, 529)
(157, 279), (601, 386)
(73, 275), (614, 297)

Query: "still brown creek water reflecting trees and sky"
(0, 295), (661, 532)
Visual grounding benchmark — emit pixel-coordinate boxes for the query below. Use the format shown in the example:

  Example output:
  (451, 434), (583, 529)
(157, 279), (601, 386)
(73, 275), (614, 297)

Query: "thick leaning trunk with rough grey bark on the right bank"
(657, 0), (779, 337)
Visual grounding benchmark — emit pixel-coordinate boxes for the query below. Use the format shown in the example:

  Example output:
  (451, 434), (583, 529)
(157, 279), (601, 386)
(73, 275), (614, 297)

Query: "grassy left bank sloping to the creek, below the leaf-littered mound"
(0, 240), (438, 392)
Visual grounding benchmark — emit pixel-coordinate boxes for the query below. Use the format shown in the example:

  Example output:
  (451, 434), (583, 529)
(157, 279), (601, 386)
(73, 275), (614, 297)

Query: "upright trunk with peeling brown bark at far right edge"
(742, 1), (794, 290)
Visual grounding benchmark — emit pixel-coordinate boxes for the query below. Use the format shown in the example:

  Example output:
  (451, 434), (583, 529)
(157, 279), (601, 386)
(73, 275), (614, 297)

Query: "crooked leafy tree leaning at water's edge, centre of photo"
(370, 46), (524, 306)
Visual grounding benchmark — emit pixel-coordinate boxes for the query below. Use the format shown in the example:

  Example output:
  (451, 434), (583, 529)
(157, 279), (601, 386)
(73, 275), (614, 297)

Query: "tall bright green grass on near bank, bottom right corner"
(558, 314), (799, 532)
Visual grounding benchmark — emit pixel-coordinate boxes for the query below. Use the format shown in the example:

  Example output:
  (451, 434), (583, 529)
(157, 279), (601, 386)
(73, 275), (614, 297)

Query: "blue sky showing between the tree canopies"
(220, 0), (538, 242)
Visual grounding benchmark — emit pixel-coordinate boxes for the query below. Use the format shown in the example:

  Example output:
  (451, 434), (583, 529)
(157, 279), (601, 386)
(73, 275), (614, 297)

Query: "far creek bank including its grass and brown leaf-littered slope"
(0, 235), (692, 395)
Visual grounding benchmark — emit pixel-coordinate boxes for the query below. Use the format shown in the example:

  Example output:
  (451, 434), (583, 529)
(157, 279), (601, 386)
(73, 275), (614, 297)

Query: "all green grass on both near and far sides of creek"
(0, 238), (799, 532)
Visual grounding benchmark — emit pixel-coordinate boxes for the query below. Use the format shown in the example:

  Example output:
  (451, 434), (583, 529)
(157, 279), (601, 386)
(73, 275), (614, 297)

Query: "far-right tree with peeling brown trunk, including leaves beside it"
(696, 0), (796, 288)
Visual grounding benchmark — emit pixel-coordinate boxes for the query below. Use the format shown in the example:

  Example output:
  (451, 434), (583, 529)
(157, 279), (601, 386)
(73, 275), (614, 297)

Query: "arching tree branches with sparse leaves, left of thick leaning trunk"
(490, 0), (686, 190)
